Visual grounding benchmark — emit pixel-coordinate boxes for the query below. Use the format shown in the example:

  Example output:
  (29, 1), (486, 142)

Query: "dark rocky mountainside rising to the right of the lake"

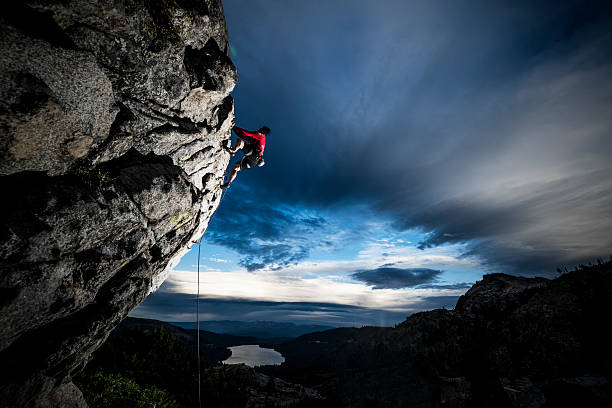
(260, 262), (612, 408)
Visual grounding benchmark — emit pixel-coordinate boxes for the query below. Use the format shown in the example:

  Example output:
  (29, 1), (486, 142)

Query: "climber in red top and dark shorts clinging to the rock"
(221, 126), (270, 189)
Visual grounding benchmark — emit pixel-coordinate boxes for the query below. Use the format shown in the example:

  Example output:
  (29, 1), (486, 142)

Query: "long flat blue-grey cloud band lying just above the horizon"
(131, 282), (412, 326)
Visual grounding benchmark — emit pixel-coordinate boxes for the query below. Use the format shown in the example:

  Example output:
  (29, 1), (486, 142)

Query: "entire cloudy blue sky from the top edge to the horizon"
(132, 0), (612, 326)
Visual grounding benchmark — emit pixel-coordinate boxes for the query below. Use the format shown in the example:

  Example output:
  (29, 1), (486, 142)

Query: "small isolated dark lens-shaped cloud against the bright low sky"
(351, 267), (442, 289)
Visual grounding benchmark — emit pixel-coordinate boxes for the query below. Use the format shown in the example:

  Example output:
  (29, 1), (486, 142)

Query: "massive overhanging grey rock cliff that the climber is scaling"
(0, 0), (237, 406)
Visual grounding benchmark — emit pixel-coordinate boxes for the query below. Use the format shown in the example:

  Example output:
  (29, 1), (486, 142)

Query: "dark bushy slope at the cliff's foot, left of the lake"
(75, 329), (246, 408)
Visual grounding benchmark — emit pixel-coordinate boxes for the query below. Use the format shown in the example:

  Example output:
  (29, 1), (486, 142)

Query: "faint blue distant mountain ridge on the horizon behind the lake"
(170, 320), (333, 340)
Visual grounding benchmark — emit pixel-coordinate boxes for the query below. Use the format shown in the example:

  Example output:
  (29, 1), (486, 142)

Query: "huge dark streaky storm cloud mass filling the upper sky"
(219, 0), (612, 273)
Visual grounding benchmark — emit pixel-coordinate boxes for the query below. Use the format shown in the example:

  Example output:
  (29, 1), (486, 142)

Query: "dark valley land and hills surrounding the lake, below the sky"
(77, 262), (612, 408)
